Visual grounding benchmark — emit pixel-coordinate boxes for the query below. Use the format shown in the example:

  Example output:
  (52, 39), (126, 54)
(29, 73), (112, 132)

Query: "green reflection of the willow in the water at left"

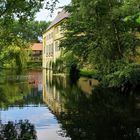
(0, 70), (39, 108)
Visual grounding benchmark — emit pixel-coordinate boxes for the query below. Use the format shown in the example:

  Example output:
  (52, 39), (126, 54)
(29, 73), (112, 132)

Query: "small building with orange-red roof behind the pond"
(30, 43), (43, 62)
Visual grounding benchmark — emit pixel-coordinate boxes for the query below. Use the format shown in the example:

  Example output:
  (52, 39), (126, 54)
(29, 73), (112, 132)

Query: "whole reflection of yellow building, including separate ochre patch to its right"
(43, 69), (98, 114)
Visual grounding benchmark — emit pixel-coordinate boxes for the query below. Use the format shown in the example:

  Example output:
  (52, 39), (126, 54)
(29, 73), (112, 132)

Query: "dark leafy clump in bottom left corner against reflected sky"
(0, 120), (37, 140)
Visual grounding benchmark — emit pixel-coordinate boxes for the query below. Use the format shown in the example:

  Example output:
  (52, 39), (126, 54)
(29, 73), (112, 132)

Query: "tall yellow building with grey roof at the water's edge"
(43, 10), (69, 69)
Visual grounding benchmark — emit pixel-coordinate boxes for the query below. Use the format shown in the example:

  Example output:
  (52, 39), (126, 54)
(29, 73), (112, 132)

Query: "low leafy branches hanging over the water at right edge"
(103, 64), (140, 87)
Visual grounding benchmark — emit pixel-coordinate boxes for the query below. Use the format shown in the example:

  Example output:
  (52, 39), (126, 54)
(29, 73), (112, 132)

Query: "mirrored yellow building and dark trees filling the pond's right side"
(43, 69), (140, 140)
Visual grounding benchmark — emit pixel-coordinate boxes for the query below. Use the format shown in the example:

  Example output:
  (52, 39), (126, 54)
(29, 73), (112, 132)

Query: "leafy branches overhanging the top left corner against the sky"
(0, 0), (58, 44)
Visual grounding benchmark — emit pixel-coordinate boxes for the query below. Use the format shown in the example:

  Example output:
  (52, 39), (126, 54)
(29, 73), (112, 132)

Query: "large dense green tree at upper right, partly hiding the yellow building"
(61, 0), (140, 88)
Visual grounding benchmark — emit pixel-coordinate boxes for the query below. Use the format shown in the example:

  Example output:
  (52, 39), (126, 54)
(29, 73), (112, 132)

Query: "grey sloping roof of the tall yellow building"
(47, 10), (70, 30)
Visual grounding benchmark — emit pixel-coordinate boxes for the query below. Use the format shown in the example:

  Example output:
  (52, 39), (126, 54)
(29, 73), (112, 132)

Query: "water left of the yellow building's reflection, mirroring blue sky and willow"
(0, 70), (71, 140)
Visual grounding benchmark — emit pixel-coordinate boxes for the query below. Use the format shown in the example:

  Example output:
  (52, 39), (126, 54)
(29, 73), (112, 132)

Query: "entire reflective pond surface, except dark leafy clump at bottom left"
(0, 70), (140, 140)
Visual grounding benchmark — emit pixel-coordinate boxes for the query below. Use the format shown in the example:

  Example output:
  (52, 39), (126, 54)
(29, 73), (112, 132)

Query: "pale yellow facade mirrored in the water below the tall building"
(43, 69), (64, 114)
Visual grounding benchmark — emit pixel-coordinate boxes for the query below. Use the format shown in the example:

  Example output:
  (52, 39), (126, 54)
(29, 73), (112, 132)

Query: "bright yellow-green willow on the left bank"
(0, 38), (30, 68)
